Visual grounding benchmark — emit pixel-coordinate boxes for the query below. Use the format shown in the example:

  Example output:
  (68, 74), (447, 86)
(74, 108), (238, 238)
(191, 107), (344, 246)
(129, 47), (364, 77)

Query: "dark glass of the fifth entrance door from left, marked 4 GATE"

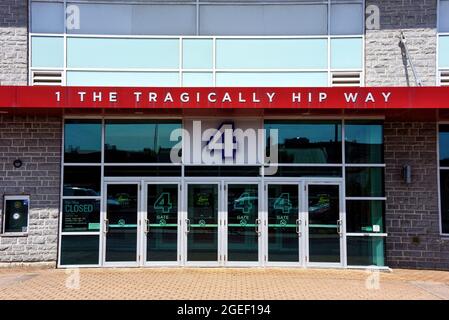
(268, 184), (299, 262)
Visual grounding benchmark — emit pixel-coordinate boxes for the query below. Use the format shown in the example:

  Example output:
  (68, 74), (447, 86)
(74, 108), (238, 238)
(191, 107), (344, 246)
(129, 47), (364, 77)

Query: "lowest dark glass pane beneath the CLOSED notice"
(61, 235), (100, 265)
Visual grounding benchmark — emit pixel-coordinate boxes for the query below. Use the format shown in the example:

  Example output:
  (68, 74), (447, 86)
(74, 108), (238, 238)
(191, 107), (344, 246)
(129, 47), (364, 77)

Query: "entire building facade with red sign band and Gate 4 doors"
(0, 0), (449, 270)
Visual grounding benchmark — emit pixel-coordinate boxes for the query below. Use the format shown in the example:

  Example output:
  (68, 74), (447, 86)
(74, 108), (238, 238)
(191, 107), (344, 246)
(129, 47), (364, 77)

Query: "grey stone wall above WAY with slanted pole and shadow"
(365, 0), (437, 86)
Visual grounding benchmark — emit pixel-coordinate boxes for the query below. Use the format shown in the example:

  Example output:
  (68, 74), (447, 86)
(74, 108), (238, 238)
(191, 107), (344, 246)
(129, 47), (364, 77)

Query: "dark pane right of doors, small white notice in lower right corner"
(346, 200), (385, 233)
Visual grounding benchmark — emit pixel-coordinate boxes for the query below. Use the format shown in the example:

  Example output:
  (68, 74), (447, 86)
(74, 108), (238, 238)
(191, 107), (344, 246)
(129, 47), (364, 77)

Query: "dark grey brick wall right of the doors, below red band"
(385, 121), (449, 270)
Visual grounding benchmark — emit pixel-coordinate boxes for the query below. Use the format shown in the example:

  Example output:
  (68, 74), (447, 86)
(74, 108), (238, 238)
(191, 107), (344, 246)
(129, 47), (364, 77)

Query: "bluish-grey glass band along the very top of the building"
(31, 0), (364, 35)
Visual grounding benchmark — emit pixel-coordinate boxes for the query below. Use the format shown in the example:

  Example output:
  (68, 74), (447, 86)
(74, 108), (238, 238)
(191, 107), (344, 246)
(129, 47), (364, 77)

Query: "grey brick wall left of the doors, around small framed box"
(0, 114), (62, 263)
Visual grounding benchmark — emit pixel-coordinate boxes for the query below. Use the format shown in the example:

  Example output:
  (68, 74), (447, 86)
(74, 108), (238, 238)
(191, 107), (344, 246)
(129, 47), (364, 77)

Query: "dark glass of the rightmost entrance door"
(308, 185), (340, 262)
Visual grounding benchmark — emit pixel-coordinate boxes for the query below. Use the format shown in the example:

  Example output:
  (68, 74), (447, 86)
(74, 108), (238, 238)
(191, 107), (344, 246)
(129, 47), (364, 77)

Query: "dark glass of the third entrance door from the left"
(187, 184), (218, 261)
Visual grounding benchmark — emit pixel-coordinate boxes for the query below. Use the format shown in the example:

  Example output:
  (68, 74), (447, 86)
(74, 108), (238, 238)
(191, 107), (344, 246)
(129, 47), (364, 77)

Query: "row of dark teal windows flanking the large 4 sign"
(64, 120), (384, 164)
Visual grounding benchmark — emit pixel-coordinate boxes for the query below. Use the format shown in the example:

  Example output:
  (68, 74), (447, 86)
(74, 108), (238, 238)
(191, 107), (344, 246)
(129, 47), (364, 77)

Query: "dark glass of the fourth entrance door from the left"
(227, 184), (259, 261)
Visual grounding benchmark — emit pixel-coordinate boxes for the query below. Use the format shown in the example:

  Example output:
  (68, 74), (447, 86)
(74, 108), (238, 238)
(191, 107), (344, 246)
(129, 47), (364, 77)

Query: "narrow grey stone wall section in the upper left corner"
(0, 0), (28, 85)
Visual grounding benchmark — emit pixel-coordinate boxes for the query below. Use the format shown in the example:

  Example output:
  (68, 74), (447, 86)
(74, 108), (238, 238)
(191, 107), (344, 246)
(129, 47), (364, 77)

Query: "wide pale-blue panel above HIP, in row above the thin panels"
(216, 39), (327, 69)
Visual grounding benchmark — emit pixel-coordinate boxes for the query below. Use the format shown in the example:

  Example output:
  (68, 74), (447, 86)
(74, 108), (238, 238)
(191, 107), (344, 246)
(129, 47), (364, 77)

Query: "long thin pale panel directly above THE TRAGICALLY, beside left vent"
(67, 71), (179, 87)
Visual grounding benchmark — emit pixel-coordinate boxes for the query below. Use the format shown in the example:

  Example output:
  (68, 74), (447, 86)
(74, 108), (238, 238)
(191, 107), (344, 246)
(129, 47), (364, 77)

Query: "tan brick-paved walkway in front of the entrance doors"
(0, 268), (449, 300)
